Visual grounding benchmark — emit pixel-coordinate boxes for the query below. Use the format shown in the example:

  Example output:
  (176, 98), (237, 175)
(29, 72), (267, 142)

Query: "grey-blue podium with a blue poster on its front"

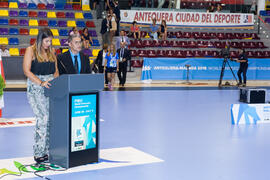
(45, 74), (104, 168)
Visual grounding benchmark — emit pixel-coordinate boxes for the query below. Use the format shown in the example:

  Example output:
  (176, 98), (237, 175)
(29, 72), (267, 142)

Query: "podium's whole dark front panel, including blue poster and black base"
(69, 92), (99, 167)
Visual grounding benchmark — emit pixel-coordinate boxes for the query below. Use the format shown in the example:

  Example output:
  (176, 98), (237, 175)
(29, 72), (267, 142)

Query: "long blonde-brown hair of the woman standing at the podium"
(33, 28), (56, 62)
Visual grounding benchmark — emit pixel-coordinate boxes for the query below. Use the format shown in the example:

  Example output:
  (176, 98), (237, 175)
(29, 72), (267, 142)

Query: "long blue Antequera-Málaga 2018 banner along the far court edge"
(141, 58), (270, 82)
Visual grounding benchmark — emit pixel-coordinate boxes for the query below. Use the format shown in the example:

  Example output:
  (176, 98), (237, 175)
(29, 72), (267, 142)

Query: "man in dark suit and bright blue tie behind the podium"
(57, 34), (91, 75)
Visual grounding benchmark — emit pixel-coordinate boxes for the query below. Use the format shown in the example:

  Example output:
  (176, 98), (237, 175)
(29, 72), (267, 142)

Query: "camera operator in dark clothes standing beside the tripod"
(236, 49), (248, 87)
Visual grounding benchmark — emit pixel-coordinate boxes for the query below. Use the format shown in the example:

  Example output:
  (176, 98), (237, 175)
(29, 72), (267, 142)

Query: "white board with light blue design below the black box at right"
(231, 104), (270, 124)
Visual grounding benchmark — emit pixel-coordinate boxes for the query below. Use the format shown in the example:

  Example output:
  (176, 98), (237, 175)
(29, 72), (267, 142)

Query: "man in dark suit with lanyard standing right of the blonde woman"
(117, 43), (131, 87)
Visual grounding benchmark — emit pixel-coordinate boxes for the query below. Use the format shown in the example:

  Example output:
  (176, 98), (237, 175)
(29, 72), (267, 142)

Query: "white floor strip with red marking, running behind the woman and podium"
(0, 117), (105, 128)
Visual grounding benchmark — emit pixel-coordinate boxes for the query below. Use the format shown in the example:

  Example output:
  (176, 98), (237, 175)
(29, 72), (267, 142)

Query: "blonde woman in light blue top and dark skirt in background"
(104, 44), (119, 90)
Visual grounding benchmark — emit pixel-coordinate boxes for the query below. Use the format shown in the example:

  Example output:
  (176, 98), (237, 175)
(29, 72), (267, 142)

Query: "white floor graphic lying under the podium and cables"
(0, 147), (164, 179)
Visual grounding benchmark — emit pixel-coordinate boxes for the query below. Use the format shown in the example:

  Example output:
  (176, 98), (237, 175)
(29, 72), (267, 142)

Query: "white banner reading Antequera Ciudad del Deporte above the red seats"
(121, 10), (254, 27)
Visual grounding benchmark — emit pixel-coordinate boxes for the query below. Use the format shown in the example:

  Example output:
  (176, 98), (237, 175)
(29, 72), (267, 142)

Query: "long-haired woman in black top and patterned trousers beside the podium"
(23, 28), (58, 163)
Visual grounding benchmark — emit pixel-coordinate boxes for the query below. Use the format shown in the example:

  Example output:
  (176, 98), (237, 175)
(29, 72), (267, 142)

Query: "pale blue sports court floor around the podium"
(0, 89), (270, 180)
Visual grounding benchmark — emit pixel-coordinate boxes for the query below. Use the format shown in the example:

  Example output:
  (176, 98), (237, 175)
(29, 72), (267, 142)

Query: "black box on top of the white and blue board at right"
(239, 88), (266, 103)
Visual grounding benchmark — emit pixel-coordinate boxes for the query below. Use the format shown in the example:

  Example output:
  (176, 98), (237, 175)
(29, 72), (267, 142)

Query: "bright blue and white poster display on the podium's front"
(71, 94), (97, 152)
